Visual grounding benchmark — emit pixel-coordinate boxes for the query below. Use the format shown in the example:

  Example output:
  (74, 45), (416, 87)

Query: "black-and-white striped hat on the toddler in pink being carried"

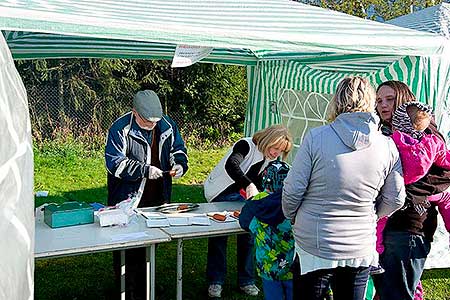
(392, 101), (432, 139)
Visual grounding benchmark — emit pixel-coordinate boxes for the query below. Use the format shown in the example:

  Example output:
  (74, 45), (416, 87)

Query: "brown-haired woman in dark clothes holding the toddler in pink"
(376, 81), (450, 300)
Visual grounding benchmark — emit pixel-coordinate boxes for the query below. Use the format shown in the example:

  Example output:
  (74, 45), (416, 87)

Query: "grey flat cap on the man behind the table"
(133, 90), (162, 122)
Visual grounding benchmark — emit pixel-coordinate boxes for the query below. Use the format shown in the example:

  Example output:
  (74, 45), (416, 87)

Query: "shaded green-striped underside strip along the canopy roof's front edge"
(4, 31), (406, 73)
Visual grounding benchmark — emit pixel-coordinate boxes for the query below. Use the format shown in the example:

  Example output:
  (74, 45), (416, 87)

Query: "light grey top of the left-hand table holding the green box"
(35, 212), (170, 258)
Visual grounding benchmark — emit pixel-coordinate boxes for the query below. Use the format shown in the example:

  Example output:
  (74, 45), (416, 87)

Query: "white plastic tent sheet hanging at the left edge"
(0, 34), (34, 300)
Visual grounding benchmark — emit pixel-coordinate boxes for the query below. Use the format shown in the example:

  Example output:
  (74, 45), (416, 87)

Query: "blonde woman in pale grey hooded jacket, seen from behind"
(282, 77), (405, 300)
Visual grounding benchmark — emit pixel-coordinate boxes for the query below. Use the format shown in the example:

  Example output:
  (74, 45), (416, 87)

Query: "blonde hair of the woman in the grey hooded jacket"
(328, 76), (376, 122)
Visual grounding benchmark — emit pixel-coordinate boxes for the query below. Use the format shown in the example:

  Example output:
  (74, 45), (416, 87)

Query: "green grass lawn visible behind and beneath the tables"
(35, 146), (450, 300)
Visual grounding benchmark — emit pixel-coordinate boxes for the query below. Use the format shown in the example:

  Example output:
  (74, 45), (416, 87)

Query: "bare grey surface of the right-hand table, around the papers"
(161, 202), (245, 239)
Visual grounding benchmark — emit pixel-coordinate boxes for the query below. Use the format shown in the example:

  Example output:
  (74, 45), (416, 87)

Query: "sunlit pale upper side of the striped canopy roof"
(0, 0), (443, 58)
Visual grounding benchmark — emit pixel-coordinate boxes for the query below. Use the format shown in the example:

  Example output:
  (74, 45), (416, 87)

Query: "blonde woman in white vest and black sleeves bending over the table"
(204, 125), (292, 298)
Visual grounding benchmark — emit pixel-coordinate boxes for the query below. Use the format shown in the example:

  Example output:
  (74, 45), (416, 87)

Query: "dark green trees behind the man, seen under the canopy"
(17, 59), (247, 146)
